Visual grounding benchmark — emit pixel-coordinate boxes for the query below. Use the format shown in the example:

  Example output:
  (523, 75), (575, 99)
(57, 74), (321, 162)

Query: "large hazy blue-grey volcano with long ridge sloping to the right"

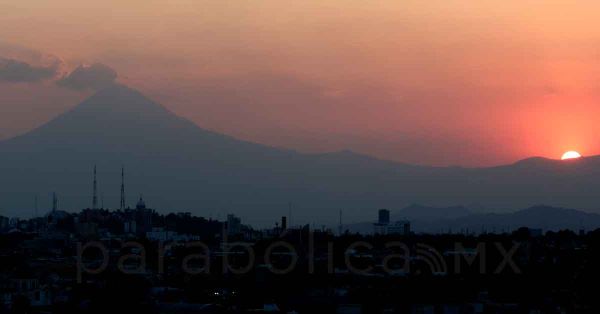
(0, 85), (600, 225)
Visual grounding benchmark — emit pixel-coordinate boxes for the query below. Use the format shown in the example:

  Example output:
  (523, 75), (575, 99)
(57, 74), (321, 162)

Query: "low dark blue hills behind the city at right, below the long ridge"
(347, 206), (600, 233)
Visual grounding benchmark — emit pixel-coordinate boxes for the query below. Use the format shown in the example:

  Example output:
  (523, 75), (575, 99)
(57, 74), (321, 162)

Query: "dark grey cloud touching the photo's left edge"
(0, 57), (58, 83)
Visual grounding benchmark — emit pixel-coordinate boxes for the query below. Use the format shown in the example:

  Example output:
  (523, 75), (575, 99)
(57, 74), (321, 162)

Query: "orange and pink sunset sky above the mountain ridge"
(0, 0), (600, 167)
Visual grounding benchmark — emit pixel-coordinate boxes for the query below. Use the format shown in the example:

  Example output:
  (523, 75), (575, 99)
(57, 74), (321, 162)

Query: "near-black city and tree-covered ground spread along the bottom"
(0, 209), (600, 313)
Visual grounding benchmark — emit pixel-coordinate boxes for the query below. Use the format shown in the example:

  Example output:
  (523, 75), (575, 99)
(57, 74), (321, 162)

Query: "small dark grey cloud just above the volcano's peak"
(56, 63), (117, 90)
